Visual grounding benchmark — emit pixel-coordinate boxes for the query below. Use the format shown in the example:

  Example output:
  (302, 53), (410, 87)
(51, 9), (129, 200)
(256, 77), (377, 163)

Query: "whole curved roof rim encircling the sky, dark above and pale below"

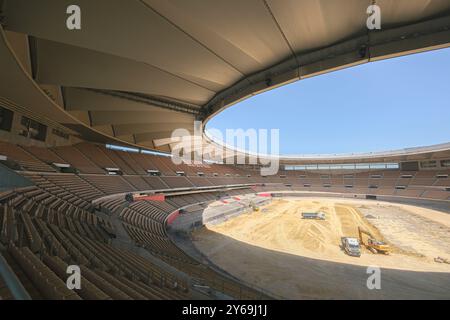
(202, 15), (450, 164)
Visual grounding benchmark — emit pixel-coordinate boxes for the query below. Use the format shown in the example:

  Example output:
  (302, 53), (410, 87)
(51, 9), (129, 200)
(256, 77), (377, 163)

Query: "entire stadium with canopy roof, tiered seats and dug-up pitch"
(0, 0), (450, 307)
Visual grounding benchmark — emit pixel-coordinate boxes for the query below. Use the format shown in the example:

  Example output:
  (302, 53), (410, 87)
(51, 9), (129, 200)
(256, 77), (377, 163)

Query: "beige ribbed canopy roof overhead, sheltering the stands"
(0, 0), (450, 160)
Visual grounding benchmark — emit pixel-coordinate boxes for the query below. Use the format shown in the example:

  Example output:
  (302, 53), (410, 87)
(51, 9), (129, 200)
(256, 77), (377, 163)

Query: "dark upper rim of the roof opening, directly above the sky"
(202, 15), (450, 125)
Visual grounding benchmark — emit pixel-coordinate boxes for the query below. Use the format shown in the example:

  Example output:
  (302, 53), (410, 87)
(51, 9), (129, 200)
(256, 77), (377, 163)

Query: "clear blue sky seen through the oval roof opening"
(207, 49), (450, 154)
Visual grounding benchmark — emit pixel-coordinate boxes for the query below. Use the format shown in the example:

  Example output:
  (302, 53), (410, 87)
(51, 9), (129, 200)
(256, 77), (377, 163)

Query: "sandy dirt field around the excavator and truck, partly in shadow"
(194, 198), (450, 299)
